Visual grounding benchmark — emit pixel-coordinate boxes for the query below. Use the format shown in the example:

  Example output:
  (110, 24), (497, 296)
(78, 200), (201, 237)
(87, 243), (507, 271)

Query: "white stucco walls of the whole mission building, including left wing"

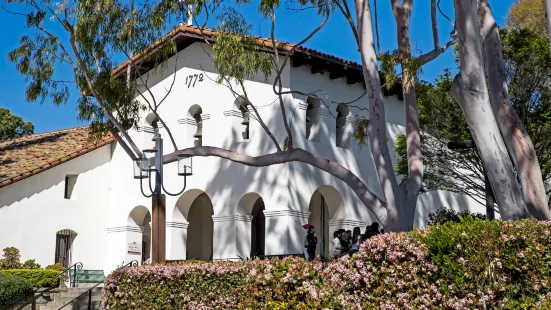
(0, 43), (484, 273)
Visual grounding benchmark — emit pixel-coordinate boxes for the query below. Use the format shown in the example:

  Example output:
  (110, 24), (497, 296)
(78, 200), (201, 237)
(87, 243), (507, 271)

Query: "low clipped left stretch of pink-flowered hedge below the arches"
(99, 258), (340, 310)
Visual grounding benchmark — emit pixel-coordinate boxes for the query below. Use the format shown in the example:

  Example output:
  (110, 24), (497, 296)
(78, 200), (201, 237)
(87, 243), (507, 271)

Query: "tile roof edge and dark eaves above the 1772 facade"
(112, 25), (403, 100)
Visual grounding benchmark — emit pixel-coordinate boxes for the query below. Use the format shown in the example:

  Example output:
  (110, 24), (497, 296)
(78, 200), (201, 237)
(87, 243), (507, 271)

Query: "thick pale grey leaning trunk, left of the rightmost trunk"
(451, 0), (529, 220)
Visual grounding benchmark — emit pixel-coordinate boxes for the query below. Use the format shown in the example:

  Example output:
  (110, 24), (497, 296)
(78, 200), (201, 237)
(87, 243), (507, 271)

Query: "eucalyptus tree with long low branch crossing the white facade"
(3, 0), (532, 231)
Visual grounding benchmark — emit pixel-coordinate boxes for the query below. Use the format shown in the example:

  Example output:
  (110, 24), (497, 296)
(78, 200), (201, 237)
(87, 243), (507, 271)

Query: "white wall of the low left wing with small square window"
(0, 145), (111, 269)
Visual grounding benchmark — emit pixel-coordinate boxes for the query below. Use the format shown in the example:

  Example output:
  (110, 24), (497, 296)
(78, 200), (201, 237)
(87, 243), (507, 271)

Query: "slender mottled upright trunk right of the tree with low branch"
(391, 0), (424, 230)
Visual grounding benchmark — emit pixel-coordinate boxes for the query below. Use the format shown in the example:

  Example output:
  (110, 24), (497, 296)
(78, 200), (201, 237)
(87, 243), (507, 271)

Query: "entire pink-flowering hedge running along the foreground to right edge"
(103, 217), (551, 309)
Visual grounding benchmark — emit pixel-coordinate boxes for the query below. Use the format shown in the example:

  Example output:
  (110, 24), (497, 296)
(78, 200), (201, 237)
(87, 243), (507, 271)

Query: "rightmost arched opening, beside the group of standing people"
(308, 185), (343, 257)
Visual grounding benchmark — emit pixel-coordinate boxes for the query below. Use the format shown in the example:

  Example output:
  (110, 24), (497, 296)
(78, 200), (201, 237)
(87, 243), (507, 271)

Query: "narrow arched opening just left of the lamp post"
(127, 206), (151, 264)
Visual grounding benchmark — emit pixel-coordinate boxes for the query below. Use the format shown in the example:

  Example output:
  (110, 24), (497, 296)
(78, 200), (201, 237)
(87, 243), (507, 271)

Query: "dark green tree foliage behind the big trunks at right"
(396, 29), (551, 204)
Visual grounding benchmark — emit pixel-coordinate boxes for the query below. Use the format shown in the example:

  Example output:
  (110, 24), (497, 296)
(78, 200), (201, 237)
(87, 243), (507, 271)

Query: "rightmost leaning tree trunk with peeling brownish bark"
(478, 0), (551, 220)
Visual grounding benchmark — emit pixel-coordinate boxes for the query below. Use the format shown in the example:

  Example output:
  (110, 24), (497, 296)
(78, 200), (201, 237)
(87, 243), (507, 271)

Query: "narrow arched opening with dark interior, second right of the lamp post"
(235, 193), (266, 258)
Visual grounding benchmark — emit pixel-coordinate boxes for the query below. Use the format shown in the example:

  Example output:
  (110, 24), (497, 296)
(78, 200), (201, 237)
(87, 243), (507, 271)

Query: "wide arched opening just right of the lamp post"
(173, 189), (214, 260)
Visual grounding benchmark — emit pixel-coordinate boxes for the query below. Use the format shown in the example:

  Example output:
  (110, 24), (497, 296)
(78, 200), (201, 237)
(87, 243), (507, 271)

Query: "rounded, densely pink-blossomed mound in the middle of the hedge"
(325, 233), (443, 309)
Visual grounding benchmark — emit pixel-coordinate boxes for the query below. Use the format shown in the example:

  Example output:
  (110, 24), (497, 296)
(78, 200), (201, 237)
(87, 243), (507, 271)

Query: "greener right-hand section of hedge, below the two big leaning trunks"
(420, 220), (551, 309)
